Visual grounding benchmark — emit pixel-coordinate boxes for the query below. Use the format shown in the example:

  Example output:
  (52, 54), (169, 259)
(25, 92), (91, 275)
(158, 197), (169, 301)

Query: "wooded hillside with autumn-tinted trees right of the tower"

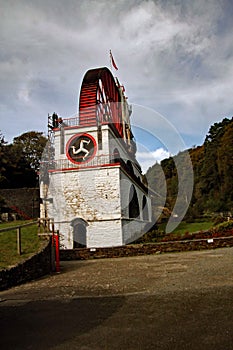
(146, 118), (233, 218)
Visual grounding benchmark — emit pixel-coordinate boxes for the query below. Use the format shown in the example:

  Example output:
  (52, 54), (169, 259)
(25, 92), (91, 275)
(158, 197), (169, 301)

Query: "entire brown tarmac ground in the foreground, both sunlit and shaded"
(0, 248), (233, 350)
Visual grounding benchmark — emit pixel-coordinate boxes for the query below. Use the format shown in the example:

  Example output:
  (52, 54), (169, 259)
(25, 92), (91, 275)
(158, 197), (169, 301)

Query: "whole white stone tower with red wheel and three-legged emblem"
(41, 67), (151, 249)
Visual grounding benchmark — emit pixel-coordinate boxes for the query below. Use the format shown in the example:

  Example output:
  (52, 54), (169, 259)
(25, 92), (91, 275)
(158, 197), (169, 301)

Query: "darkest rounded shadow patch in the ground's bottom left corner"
(0, 297), (124, 350)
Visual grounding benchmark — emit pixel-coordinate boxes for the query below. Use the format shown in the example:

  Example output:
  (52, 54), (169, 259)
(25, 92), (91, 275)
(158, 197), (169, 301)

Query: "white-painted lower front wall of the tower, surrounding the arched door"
(45, 166), (121, 248)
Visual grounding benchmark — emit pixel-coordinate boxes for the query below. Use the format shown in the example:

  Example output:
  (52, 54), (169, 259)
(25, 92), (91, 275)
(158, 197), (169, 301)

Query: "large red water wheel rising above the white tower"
(79, 67), (122, 136)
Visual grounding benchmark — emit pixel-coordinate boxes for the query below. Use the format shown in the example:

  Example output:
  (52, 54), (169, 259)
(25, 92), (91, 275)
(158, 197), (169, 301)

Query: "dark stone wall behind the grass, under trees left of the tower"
(0, 188), (40, 219)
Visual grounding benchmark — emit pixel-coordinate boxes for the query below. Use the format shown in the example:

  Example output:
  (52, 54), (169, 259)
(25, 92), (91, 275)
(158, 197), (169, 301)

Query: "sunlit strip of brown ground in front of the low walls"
(0, 248), (233, 300)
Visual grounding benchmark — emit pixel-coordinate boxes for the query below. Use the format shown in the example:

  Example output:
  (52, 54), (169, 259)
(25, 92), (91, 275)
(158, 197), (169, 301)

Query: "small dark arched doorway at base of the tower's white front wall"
(71, 218), (88, 249)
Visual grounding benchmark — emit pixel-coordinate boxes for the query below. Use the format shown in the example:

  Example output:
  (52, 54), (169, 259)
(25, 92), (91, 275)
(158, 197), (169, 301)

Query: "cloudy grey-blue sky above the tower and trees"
(0, 0), (233, 172)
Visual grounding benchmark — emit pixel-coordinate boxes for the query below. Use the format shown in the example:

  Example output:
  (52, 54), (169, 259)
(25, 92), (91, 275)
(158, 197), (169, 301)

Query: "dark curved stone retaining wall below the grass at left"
(0, 240), (54, 290)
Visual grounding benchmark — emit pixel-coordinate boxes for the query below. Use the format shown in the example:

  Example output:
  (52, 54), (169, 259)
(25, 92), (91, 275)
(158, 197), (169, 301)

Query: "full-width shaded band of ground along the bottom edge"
(0, 286), (233, 350)
